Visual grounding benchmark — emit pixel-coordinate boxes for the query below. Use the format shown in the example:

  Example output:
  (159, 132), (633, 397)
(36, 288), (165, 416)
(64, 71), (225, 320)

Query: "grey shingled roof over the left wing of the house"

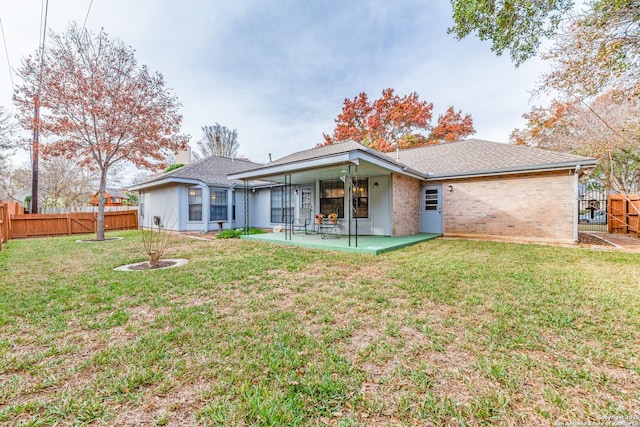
(129, 156), (261, 191)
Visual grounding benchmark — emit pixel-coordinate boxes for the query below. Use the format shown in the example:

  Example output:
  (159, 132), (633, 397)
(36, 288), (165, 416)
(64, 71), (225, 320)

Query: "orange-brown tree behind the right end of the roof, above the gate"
(511, 92), (640, 194)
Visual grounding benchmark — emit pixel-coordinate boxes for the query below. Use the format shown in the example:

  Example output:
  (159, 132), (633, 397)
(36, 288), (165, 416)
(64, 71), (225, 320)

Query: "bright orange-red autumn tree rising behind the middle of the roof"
(318, 89), (475, 152)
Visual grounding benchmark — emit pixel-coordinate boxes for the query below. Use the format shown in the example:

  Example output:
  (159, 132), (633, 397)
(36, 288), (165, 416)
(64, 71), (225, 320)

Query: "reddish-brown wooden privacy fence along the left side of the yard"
(6, 210), (138, 240)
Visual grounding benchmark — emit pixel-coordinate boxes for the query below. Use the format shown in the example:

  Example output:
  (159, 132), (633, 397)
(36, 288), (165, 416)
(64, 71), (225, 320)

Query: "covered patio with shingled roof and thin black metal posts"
(229, 141), (424, 242)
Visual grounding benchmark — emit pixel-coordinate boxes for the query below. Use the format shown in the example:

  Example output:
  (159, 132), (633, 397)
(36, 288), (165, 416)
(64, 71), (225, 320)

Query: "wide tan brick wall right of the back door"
(440, 171), (575, 243)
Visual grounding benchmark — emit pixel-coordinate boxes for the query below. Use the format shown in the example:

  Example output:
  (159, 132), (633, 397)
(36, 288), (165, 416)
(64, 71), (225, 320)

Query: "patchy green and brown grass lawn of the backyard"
(0, 232), (640, 426)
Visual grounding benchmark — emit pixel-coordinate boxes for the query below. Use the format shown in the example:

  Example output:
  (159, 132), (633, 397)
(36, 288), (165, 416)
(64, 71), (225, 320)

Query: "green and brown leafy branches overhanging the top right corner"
(449, 0), (640, 99)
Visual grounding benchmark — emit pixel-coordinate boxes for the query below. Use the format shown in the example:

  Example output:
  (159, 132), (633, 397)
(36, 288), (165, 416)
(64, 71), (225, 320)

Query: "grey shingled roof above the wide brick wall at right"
(393, 139), (597, 179)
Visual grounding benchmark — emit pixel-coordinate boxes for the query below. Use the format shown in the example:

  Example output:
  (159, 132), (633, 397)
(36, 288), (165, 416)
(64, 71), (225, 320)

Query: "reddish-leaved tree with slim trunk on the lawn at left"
(16, 24), (187, 240)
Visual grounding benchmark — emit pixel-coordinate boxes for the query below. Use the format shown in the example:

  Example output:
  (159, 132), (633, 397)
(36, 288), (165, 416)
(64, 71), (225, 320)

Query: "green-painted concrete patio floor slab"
(241, 232), (441, 255)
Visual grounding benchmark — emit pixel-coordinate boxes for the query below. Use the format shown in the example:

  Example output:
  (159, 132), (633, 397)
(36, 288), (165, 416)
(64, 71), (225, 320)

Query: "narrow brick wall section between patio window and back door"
(391, 174), (420, 236)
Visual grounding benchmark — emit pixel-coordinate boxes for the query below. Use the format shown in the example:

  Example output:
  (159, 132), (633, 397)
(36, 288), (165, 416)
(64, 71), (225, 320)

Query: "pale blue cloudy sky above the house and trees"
(0, 0), (544, 174)
